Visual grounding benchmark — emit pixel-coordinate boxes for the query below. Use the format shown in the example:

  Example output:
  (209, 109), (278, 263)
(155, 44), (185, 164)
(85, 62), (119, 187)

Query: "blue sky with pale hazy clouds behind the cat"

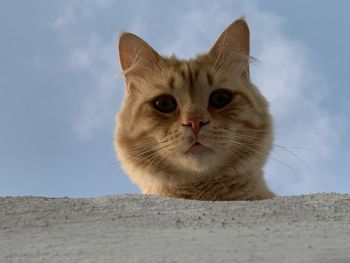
(0, 0), (350, 197)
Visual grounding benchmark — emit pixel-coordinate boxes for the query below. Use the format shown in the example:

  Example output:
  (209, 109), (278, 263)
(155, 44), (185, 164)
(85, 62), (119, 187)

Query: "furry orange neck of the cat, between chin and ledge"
(140, 169), (275, 200)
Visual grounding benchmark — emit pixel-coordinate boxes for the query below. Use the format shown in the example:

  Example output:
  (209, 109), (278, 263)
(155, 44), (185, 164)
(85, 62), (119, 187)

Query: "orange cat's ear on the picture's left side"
(119, 32), (160, 81)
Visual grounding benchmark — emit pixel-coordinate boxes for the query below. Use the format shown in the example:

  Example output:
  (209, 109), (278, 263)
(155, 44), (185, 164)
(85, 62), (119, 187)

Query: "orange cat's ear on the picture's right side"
(209, 18), (250, 80)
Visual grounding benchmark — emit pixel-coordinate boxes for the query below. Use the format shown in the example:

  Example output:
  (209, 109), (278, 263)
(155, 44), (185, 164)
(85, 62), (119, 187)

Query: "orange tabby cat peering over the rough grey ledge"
(114, 18), (275, 200)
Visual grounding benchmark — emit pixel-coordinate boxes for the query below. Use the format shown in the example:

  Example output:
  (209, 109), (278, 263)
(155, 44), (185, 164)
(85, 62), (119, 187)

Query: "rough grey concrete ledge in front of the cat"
(0, 194), (350, 263)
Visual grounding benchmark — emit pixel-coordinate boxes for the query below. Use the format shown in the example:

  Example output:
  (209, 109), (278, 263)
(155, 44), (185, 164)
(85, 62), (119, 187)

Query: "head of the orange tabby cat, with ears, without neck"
(116, 20), (271, 178)
